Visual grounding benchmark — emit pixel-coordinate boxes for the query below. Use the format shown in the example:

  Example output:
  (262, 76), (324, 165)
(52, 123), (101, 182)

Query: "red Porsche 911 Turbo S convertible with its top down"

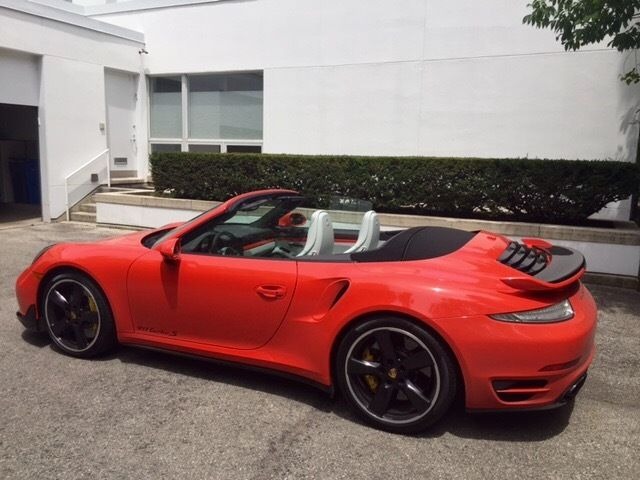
(16, 190), (596, 433)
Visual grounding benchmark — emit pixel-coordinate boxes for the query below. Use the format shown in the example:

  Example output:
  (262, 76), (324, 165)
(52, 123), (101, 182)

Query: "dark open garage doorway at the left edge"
(0, 103), (42, 223)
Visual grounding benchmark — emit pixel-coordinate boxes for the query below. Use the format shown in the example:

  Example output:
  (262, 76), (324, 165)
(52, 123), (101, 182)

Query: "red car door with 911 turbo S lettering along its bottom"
(128, 250), (297, 349)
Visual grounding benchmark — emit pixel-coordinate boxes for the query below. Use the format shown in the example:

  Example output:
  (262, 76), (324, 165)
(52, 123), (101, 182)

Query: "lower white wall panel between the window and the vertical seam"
(264, 62), (421, 155)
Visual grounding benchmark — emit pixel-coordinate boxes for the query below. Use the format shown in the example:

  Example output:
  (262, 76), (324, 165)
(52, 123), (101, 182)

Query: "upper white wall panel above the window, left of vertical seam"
(93, 0), (425, 73)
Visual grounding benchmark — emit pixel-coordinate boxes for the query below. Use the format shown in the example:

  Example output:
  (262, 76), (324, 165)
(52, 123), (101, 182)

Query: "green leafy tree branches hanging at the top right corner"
(522, 0), (640, 84)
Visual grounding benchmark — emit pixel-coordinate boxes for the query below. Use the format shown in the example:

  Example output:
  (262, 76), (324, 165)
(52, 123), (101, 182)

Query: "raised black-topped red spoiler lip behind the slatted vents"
(500, 246), (586, 291)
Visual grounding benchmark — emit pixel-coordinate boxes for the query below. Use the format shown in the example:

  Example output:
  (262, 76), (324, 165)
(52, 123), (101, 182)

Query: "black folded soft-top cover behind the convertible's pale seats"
(351, 227), (476, 262)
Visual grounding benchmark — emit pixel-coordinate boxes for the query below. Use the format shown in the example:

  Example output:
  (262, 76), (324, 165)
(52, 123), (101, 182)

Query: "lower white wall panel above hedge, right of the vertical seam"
(419, 51), (637, 160)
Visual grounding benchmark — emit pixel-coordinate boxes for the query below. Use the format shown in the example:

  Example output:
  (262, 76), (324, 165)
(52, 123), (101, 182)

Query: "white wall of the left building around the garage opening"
(0, 2), (146, 220)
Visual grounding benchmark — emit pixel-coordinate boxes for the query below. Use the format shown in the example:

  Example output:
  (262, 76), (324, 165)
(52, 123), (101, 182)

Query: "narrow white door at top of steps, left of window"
(104, 70), (138, 177)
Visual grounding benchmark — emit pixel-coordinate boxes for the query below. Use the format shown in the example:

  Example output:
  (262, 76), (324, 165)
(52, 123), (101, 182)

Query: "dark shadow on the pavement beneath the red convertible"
(111, 347), (573, 442)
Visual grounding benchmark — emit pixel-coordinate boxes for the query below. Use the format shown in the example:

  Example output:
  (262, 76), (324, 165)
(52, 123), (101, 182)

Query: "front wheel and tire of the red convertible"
(40, 272), (117, 358)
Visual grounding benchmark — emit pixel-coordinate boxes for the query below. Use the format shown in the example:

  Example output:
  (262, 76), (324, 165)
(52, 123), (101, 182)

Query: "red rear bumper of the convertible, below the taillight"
(456, 286), (596, 410)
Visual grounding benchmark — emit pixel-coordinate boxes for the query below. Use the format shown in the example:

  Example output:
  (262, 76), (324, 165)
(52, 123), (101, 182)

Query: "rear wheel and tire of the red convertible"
(335, 316), (457, 433)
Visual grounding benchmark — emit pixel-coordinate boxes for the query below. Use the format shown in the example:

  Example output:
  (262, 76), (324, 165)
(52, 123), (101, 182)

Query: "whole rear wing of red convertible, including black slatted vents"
(498, 239), (586, 291)
